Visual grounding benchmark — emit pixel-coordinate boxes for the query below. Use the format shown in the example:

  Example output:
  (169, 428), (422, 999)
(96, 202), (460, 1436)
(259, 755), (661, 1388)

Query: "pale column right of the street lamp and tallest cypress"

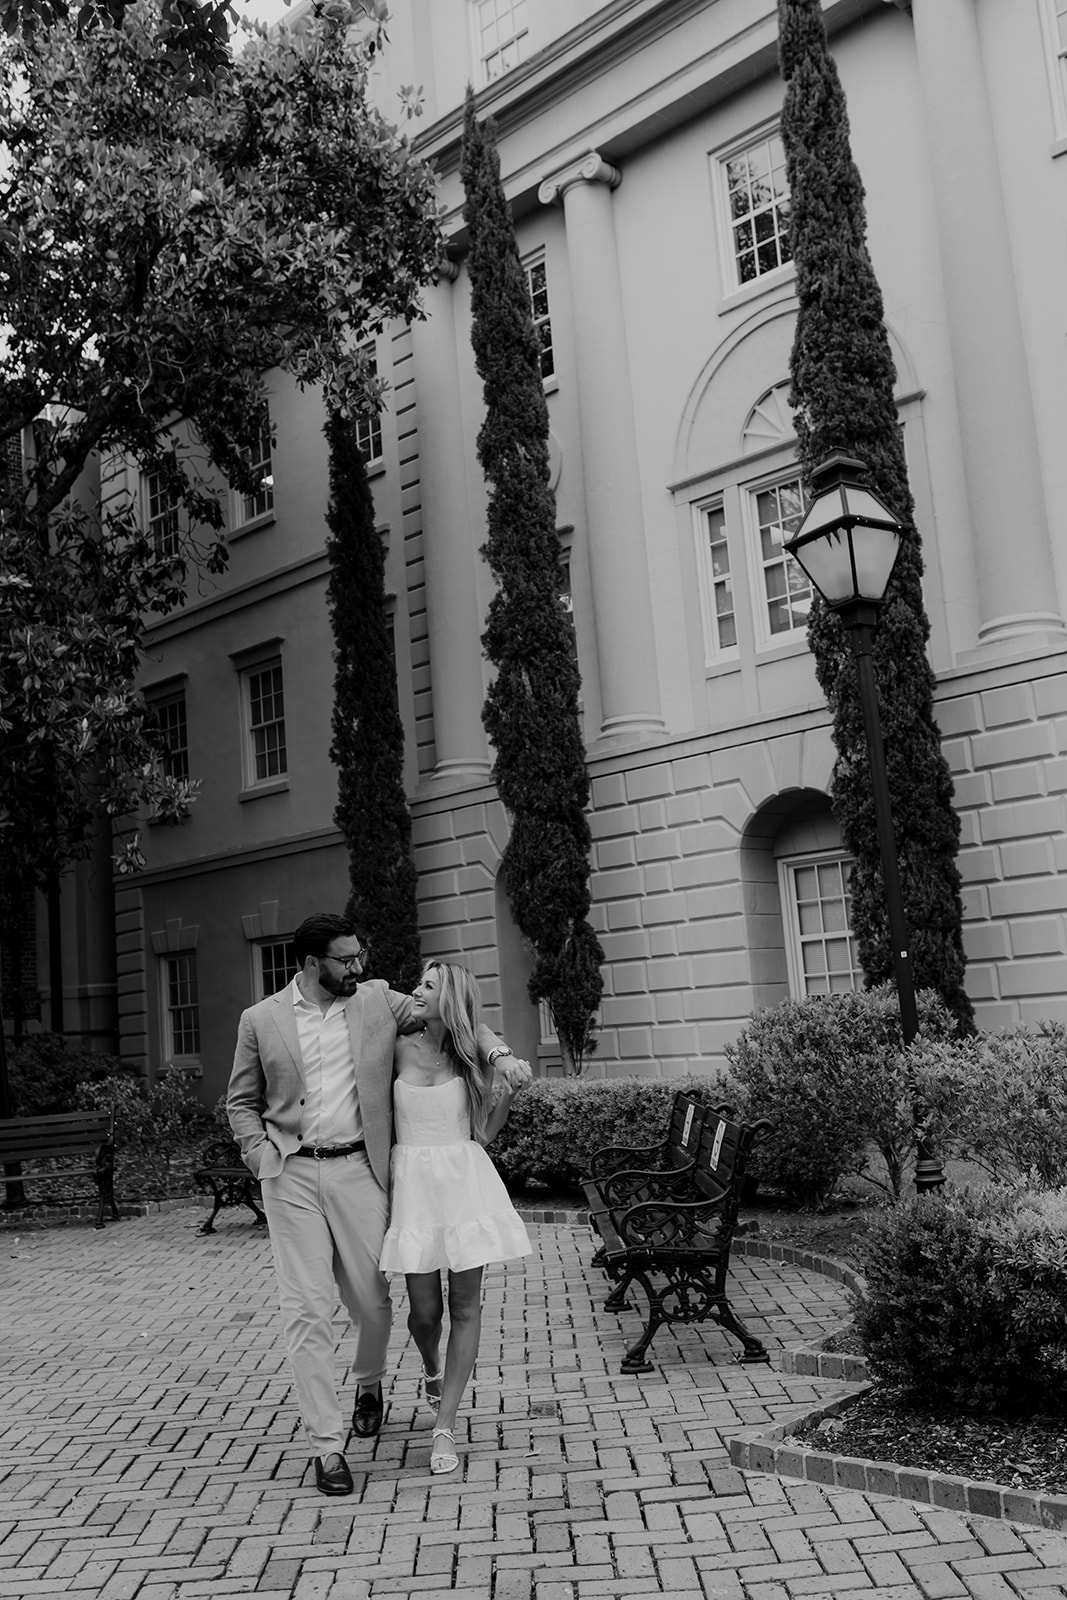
(912, 0), (1067, 658)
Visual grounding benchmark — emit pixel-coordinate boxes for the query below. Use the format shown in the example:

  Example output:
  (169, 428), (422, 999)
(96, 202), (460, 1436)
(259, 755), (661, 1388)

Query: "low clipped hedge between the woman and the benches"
(491, 1075), (735, 1187)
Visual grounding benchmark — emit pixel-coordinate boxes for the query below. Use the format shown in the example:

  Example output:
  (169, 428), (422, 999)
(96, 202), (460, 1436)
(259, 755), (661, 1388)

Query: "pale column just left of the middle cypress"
(411, 262), (490, 787)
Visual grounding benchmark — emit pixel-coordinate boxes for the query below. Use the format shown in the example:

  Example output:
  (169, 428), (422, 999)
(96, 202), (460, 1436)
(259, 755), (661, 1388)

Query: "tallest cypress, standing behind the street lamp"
(777, 0), (973, 1027)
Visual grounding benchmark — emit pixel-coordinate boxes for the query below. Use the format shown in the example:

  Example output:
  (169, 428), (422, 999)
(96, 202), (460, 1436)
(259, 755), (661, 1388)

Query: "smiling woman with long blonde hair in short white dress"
(381, 962), (531, 1472)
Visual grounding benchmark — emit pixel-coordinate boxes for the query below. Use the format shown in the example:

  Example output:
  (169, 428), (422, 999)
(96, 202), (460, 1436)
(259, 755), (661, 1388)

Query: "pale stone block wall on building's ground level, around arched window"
(414, 651), (1067, 1075)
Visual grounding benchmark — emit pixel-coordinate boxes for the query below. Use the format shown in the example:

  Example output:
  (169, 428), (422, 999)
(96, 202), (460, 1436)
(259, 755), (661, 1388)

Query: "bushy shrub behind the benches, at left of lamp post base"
(723, 984), (955, 1206)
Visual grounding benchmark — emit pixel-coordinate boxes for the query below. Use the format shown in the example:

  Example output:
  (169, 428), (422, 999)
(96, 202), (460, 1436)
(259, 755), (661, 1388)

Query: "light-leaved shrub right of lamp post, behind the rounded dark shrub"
(907, 1022), (1067, 1187)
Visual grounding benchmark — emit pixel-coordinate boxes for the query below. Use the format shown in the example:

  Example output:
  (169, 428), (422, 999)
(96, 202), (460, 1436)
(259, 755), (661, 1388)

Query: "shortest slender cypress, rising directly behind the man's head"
(326, 413), (419, 989)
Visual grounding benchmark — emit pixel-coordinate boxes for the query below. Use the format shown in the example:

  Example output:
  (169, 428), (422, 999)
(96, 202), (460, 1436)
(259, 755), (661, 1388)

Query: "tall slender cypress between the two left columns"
(462, 90), (603, 1072)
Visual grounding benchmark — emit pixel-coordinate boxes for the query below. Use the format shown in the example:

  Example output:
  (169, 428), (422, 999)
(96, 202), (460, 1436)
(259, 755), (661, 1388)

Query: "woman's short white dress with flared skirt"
(381, 1078), (533, 1272)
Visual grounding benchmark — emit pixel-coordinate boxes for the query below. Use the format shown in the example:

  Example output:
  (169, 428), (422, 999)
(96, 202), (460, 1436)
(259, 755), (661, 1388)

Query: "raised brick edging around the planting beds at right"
(726, 1237), (1067, 1533)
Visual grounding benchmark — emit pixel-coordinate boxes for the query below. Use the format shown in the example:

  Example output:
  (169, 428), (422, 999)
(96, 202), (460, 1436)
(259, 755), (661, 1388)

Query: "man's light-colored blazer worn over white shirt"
(226, 978), (501, 1189)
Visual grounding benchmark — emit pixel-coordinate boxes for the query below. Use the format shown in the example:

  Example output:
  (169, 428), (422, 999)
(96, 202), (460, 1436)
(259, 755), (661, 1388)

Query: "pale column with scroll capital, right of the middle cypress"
(537, 150), (665, 744)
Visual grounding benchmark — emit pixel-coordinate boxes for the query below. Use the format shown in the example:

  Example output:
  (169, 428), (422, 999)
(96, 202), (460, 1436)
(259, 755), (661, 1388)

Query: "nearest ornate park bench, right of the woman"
(587, 1110), (771, 1373)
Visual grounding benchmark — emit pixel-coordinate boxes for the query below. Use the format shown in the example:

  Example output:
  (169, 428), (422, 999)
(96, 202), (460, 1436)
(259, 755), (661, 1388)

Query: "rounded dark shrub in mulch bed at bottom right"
(854, 1186), (1067, 1410)
